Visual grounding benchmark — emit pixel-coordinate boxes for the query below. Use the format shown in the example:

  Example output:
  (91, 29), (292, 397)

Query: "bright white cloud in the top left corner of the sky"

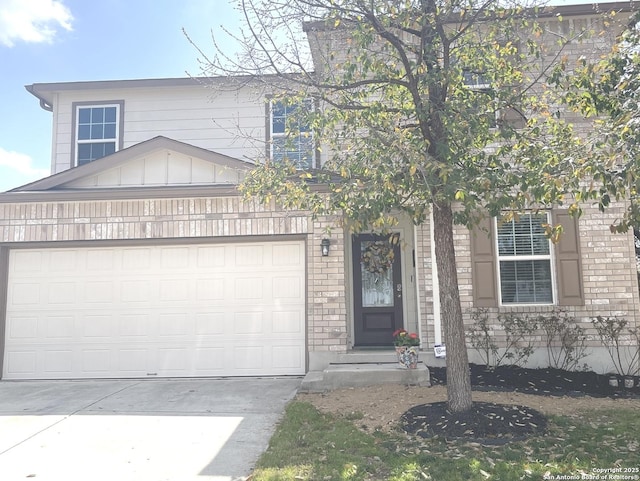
(0, 0), (73, 47)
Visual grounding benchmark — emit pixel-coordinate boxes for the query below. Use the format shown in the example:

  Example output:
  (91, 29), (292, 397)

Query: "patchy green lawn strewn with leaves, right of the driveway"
(251, 401), (640, 481)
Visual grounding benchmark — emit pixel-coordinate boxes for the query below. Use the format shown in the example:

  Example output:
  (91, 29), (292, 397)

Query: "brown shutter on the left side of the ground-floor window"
(471, 218), (498, 307)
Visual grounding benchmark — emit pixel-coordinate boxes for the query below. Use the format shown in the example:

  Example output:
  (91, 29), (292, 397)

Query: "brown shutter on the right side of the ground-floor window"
(552, 210), (584, 306)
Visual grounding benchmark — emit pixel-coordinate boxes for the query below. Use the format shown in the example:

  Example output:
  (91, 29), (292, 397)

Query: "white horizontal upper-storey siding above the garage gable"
(51, 85), (265, 173)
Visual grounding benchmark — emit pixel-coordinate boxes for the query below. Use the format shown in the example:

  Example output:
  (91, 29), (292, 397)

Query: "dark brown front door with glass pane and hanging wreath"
(353, 234), (404, 347)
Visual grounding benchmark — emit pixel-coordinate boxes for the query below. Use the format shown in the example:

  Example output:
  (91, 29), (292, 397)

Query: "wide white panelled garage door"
(3, 241), (305, 379)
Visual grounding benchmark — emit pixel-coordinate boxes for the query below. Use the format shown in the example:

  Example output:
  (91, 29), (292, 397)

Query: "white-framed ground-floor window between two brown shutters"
(497, 214), (553, 304)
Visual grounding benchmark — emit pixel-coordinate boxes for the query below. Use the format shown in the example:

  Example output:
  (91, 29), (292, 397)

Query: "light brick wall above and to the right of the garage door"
(0, 193), (347, 352)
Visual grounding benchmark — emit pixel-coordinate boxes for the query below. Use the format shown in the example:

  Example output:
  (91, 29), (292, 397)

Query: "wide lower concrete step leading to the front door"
(299, 359), (431, 392)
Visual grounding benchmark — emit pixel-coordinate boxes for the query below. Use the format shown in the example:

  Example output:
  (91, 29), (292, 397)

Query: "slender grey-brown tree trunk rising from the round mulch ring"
(433, 202), (471, 412)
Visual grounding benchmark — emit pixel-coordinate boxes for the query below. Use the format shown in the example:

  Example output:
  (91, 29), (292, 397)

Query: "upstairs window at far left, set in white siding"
(75, 103), (122, 165)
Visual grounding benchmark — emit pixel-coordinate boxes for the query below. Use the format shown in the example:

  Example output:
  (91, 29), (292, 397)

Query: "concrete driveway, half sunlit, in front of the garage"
(0, 378), (300, 481)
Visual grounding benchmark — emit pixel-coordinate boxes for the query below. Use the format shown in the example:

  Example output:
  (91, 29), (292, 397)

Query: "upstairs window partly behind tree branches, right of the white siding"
(270, 99), (314, 169)
